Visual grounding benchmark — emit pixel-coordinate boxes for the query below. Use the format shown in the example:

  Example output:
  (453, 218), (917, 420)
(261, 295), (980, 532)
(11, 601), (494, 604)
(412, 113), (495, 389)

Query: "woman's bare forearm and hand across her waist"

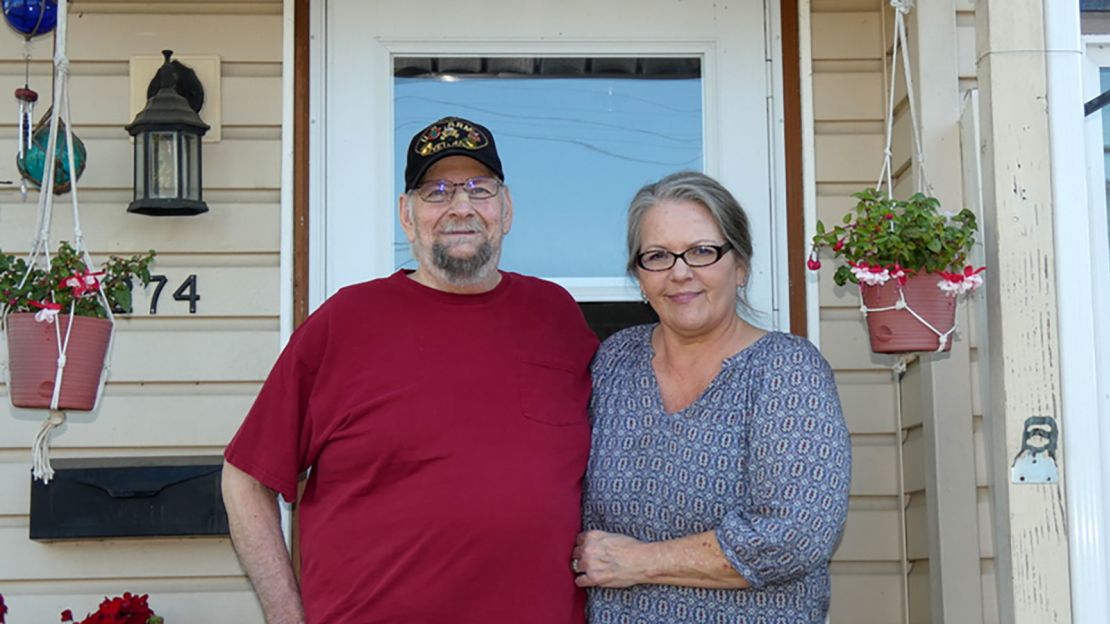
(572, 531), (748, 590)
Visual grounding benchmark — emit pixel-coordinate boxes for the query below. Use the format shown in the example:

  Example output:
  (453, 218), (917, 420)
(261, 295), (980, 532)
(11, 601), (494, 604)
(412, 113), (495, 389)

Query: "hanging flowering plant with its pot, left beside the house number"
(0, 242), (154, 411)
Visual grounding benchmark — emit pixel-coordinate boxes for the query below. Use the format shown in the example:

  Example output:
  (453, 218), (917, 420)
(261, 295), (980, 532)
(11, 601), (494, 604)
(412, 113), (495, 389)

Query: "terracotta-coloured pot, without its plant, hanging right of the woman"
(859, 273), (956, 353)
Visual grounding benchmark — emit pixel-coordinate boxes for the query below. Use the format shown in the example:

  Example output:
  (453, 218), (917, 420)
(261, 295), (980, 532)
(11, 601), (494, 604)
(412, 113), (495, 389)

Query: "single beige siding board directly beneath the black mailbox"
(0, 527), (240, 581)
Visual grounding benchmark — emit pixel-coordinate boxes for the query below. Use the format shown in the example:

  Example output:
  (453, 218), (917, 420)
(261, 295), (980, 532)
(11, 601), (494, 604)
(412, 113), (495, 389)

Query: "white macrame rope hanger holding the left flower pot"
(2, 0), (115, 483)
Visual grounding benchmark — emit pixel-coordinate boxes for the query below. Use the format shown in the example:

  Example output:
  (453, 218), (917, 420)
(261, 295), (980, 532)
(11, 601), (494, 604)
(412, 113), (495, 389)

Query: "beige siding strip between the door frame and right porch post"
(811, 0), (906, 624)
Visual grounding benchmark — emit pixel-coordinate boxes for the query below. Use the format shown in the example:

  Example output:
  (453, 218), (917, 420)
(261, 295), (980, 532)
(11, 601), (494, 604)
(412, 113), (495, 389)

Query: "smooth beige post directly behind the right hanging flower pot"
(906, 0), (982, 624)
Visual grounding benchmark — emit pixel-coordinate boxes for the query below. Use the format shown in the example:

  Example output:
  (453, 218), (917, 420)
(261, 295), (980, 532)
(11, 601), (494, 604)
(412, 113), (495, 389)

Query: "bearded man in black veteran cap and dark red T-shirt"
(223, 118), (597, 624)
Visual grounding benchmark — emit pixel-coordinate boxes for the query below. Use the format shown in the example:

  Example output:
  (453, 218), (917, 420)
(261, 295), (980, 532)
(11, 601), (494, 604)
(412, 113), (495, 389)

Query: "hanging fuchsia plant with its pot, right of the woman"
(807, 189), (986, 353)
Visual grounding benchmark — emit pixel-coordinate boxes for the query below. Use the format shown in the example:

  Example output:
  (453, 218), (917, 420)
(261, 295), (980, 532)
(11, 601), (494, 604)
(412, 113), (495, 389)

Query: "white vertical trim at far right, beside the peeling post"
(1045, 0), (1110, 622)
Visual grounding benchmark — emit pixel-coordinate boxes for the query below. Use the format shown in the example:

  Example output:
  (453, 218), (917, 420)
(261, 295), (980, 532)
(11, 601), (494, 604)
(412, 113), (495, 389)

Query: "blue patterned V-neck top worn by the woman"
(583, 325), (851, 624)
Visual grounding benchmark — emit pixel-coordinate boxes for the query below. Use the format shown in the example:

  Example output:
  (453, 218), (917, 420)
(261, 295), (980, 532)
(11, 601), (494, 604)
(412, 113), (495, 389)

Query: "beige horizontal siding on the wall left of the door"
(0, 0), (282, 624)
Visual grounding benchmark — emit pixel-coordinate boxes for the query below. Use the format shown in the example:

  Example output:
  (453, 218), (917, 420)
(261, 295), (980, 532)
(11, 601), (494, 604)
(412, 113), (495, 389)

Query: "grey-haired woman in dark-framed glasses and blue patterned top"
(571, 172), (850, 624)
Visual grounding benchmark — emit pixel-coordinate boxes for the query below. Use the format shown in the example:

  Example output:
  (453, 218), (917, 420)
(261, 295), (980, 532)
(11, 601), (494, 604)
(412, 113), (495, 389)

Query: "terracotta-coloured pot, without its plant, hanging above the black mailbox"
(7, 313), (112, 411)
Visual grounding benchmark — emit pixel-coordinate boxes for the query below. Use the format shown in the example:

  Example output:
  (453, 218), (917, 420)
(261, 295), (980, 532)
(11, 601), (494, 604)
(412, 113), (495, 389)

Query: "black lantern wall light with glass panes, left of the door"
(125, 50), (209, 217)
